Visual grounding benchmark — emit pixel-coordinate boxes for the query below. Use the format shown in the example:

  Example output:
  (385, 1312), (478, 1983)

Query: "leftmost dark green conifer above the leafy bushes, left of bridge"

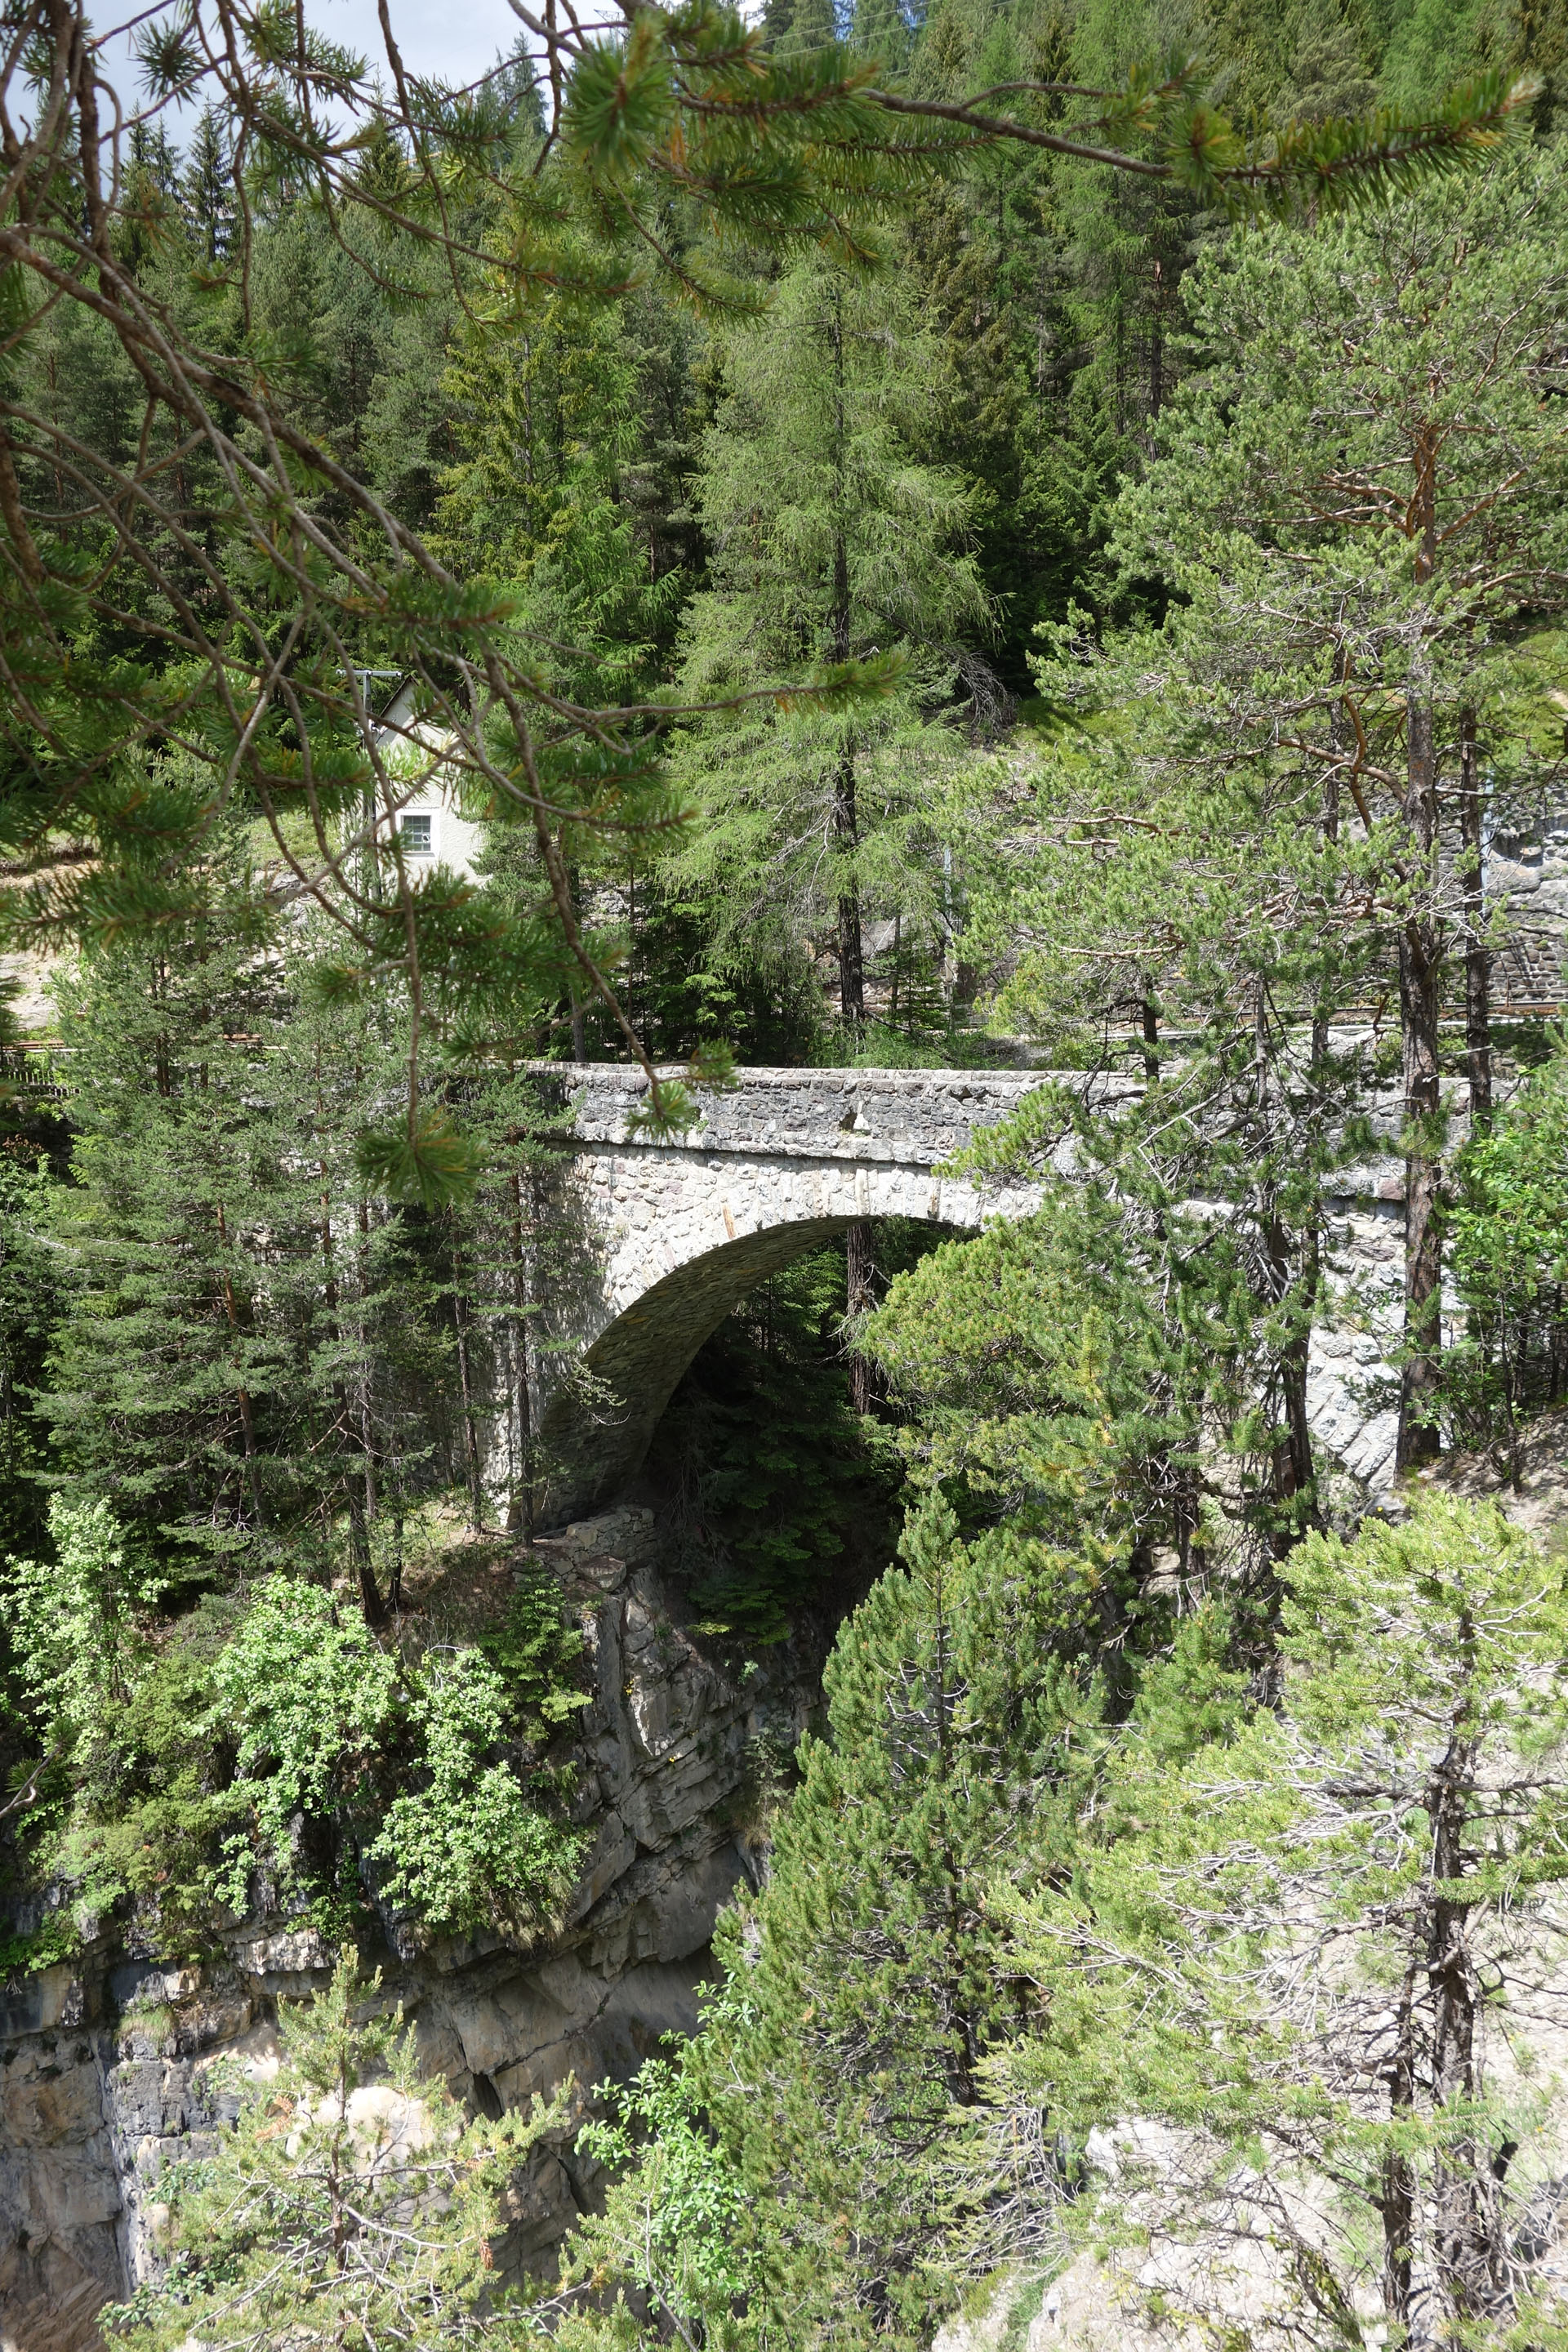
(45, 912), (294, 1564)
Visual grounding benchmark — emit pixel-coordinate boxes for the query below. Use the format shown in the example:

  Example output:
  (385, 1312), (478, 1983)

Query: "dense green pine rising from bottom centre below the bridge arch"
(552, 1503), (1100, 2345)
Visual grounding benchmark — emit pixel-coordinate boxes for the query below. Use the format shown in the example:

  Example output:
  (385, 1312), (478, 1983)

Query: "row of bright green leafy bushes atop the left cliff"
(0, 1500), (583, 1969)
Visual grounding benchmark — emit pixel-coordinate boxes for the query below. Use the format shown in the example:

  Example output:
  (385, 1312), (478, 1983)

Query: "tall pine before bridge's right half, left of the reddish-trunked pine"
(945, 576), (1378, 1533)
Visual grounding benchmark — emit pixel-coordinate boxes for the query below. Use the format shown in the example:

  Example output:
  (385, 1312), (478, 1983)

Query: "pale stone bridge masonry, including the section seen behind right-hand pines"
(523, 1058), (1419, 1521)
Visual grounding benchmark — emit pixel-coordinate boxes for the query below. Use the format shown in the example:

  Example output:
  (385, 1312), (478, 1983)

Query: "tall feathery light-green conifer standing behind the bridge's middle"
(675, 261), (990, 1026)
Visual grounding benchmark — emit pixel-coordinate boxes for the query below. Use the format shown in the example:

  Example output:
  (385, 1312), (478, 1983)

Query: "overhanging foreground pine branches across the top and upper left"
(0, 0), (1533, 1171)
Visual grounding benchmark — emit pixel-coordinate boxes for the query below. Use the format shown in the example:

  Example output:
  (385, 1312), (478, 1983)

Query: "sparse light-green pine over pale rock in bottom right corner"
(990, 1494), (1568, 2347)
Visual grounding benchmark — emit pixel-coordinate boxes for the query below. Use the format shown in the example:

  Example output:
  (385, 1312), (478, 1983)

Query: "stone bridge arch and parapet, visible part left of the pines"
(532, 1063), (1041, 1521)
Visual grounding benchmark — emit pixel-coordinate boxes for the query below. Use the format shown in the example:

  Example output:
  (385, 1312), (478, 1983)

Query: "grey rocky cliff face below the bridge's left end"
(0, 1508), (818, 2352)
